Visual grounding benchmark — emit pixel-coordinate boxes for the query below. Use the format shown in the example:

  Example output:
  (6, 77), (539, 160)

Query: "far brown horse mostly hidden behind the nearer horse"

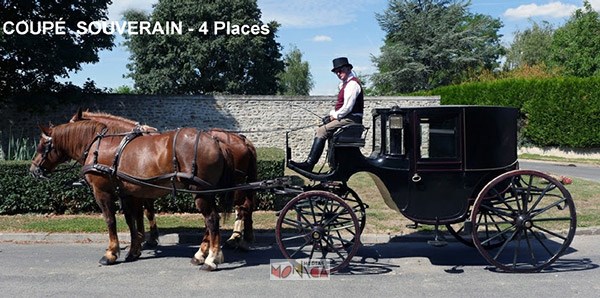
(71, 109), (257, 248)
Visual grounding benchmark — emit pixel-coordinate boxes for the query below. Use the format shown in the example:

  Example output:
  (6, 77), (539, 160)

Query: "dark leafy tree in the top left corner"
(0, 0), (113, 99)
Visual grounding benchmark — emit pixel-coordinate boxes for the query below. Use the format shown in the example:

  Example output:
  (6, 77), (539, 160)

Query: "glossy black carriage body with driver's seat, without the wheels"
(288, 106), (518, 224)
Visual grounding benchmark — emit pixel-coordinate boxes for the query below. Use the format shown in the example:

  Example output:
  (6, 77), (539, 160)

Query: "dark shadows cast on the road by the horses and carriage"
(115, 229), (599, 275)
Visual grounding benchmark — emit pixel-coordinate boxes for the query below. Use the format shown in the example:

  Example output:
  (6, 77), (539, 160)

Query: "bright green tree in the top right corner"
(550, 1), (600, 77)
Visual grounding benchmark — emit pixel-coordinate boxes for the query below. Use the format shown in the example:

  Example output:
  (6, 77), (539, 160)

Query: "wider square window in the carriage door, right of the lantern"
(419, 117), (458, 158)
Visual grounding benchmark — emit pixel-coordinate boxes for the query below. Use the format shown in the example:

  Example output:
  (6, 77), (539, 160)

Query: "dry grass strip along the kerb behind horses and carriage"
(0, 173), (600, 234)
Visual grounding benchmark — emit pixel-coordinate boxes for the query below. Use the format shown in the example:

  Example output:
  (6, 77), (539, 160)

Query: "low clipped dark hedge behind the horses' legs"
(0, 148), (284, 215)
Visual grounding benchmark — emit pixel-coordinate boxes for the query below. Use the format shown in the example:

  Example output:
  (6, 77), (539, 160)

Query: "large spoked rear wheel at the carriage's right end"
(471, 170), (577, 272)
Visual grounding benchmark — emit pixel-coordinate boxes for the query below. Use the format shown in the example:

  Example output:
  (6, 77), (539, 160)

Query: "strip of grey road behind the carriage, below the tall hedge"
(519, 161), (600, 182)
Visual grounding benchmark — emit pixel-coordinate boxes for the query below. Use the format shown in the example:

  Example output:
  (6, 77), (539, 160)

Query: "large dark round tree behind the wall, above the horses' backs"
(125, 0), (283, 94)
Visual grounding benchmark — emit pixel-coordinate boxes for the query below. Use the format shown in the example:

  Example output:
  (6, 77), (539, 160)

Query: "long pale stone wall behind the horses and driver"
(0, 95), (440, 159)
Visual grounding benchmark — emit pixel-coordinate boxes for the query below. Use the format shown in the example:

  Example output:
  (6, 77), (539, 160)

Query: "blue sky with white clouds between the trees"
(66, 0), (600, 95)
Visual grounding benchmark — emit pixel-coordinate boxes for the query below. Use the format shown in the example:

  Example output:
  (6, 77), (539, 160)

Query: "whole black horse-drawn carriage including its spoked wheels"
(284, 106), (576, 272)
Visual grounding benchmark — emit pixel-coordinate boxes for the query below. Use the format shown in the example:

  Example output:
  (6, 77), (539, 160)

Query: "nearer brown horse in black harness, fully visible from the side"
(30, 121), (231, 270)
